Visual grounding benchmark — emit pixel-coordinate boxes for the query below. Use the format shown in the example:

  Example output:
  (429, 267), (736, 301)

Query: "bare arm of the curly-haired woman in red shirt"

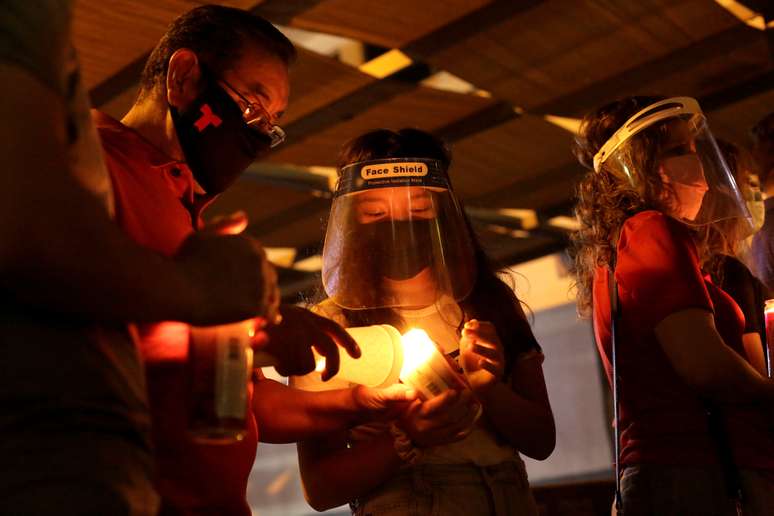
(655, 309), (774, 404)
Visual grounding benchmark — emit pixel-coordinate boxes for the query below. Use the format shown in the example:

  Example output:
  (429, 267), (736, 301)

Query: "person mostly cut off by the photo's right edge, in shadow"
(750, 113), (774, 290)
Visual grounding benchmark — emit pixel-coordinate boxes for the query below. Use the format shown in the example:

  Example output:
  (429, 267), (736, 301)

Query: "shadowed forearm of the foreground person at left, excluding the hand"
(1, 202), (202, 322)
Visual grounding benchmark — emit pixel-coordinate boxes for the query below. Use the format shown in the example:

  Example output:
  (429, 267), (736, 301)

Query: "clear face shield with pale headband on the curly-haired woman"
(594, 97), (751, 230)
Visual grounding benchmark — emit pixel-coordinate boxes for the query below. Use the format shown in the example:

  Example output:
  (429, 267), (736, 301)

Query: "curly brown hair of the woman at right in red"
(570, 96), (675, 315)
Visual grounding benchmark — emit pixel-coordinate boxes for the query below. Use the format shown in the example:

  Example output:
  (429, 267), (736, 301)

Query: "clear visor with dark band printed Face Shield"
(322, 158), (475, 310)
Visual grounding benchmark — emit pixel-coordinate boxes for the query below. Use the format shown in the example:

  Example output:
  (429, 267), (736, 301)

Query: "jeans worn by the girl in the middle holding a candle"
(353, 462), (538, 516)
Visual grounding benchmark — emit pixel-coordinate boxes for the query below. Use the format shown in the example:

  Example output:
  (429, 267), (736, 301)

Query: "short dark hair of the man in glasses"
(140, 5), (296, 97)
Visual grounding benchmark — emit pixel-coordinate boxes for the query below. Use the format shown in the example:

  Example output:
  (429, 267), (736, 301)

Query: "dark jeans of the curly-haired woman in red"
(621, 464), (774, 516)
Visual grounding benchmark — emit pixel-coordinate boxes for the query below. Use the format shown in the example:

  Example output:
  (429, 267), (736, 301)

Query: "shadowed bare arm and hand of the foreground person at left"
(0, 64), (270, 324)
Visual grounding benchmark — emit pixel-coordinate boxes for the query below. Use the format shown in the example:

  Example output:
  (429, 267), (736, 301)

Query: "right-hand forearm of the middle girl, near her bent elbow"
(478, 382), (556, 460)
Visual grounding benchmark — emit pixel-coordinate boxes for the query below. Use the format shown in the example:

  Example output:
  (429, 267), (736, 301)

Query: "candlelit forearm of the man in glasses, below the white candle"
(253, 379), (361, 443)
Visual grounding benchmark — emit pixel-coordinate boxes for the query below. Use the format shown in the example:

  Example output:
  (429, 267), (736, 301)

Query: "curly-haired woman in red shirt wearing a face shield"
(574, 97), (774, 516)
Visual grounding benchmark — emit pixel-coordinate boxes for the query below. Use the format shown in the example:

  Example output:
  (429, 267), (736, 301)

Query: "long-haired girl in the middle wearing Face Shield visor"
(293, 129), (555, 516)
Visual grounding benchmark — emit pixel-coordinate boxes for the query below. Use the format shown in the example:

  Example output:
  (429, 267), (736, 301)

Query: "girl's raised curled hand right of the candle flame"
(460, 319), (505, 394)
